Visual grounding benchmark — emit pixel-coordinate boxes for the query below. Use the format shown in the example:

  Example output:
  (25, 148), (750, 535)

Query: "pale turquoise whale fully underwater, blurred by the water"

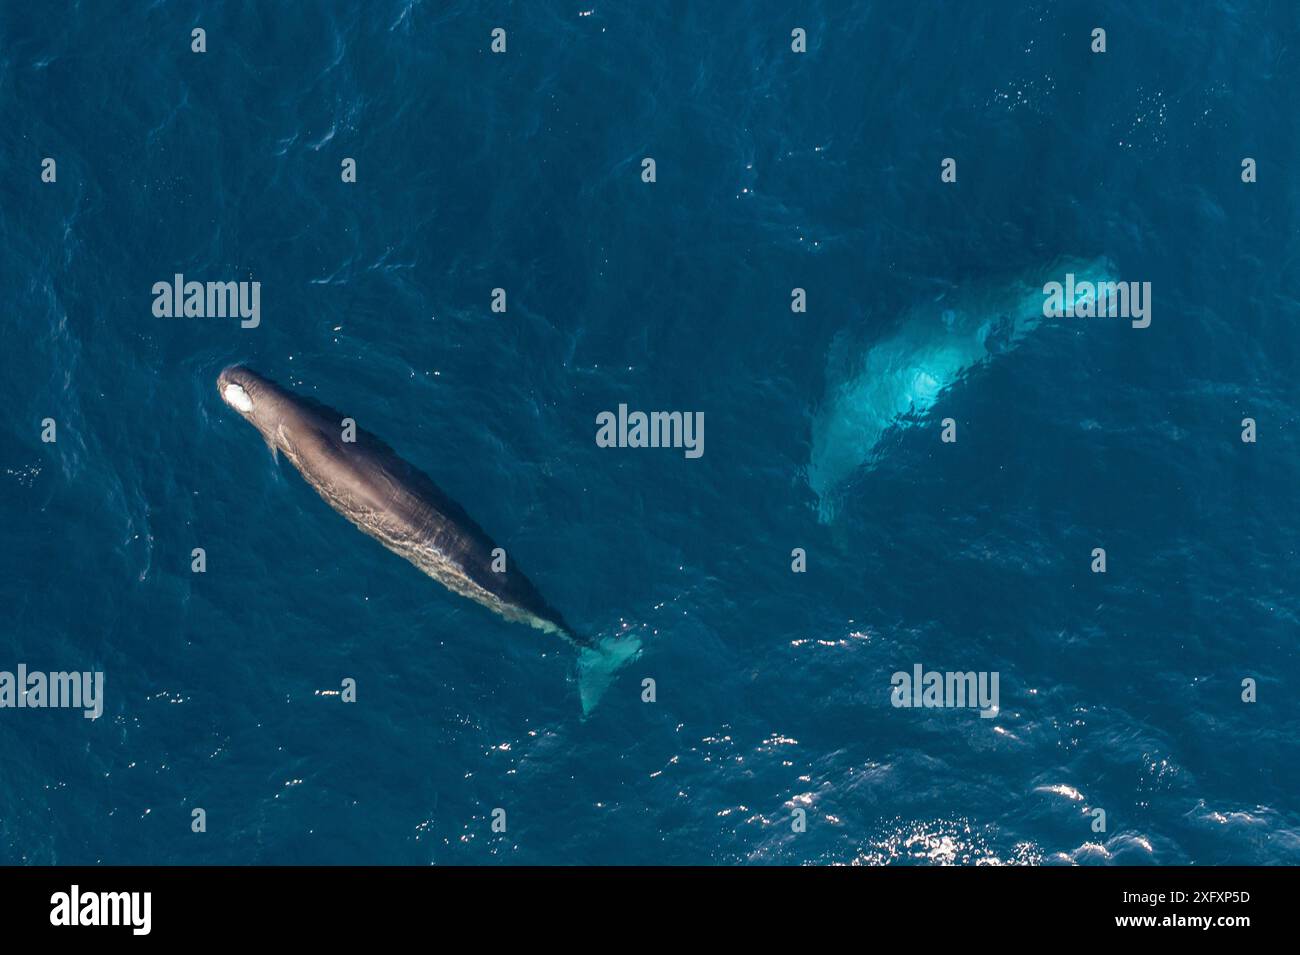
(807, 257), (1115, 524)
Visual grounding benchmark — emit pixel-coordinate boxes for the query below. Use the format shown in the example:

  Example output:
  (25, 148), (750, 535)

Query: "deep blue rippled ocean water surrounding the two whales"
(0, 0), (1300, 864)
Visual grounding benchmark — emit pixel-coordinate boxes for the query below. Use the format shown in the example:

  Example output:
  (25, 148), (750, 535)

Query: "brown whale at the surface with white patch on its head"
(217, 366), (640, 711)
